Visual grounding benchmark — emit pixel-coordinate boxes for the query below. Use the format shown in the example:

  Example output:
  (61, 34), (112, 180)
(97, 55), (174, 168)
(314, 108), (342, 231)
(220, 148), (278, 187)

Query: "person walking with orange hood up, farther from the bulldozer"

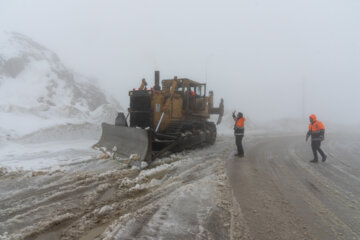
(306, 114), (327, 163)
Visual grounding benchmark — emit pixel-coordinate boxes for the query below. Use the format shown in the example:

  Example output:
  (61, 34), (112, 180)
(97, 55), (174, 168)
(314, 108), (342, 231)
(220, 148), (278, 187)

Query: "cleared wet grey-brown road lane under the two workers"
(227, 135), (360, 240)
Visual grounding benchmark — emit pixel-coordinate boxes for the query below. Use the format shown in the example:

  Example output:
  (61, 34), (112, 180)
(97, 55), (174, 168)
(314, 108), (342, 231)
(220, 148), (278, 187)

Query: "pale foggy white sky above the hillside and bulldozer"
(0, 0), (360, 122)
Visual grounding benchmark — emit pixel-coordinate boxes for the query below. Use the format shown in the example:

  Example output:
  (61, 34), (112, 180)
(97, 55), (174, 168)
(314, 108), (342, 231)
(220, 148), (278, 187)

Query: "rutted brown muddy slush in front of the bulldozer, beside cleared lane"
(0, 138), (246, 240)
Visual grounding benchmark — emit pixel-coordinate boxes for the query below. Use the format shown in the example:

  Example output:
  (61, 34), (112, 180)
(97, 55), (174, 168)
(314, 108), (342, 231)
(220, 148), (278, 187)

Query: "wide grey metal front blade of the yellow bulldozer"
(93, 123), (152, 161)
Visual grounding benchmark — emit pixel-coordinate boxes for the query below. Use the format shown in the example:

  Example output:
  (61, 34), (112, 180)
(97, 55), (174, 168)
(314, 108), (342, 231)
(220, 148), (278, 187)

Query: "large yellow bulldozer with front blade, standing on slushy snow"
(94, 71), (224, 162)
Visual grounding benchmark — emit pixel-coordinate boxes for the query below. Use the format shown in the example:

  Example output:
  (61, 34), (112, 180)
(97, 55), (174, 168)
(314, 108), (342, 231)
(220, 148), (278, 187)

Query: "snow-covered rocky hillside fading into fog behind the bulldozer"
(0, 32), (121, 137)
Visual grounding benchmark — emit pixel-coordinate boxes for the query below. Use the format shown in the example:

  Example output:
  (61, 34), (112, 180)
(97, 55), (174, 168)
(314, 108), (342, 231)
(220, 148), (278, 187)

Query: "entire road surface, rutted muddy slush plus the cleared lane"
(0, 135), (360, 240)
